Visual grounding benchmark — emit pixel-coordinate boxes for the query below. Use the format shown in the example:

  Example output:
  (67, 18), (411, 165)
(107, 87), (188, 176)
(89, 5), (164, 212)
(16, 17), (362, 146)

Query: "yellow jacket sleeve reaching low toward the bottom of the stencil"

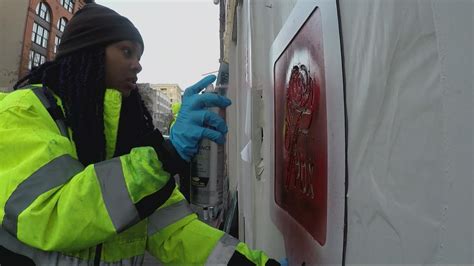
(147, 189), (279, 266)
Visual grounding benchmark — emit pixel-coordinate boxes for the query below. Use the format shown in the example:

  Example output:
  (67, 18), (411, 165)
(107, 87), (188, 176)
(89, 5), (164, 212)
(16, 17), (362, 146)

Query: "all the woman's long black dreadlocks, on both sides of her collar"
(14, 47), (154, 165)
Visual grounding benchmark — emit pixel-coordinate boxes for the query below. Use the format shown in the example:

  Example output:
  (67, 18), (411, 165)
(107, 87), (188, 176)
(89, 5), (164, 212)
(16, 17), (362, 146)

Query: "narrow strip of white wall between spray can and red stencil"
(227, 0), (296, 258)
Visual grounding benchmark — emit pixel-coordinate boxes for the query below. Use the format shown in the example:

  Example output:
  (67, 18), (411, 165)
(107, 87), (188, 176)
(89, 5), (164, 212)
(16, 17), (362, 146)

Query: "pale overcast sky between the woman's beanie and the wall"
(96, 0), (219, 90)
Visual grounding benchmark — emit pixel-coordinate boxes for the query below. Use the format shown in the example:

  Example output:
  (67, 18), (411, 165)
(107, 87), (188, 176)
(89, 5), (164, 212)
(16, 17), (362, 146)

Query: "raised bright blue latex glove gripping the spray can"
(170, 75), (231, 162)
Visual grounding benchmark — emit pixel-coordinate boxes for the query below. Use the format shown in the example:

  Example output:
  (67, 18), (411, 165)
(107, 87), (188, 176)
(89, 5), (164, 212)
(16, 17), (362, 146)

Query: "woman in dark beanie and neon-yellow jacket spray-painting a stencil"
(0, 4), (278, 265)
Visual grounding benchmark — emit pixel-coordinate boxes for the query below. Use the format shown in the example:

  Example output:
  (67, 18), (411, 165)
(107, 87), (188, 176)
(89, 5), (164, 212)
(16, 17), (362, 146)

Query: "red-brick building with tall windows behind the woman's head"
(0, 0), (90, 90)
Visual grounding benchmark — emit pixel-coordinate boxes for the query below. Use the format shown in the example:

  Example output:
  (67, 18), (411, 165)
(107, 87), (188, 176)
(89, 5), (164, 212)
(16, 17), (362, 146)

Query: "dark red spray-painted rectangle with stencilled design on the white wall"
(274, 9), (327, 245)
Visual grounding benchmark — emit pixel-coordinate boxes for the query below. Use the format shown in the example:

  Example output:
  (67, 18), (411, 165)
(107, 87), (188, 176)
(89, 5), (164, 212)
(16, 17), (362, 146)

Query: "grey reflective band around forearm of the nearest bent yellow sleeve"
(94, 157), (140, 233)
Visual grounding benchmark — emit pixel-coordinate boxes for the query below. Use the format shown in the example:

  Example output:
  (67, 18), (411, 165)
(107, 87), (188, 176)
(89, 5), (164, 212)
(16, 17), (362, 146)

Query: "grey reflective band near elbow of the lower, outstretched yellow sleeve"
(148, 200), (193, 236)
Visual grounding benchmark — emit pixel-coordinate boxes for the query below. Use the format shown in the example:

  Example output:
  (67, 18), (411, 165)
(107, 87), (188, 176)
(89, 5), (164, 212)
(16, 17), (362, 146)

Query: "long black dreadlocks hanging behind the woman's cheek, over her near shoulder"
(14, 47), (105, 165)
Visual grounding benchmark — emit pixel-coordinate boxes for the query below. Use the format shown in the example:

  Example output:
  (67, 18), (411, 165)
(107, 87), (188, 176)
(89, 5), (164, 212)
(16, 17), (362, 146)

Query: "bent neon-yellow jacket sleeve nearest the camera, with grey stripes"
(0, 95), (175, 251)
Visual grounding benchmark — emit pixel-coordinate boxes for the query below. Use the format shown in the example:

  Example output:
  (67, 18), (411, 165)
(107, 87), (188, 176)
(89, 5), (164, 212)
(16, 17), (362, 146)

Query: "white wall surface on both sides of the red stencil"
(229, 0), (474, 265)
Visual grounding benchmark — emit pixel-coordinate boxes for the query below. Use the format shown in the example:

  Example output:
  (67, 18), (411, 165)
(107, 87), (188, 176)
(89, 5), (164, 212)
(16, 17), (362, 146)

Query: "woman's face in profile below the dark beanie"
(105, 41), (143, 97)
